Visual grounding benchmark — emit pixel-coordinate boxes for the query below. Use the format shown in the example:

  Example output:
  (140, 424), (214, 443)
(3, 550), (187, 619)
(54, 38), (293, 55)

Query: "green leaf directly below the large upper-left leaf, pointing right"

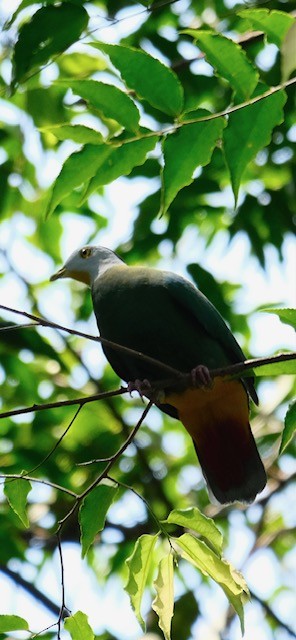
(62, 80), (140, 133)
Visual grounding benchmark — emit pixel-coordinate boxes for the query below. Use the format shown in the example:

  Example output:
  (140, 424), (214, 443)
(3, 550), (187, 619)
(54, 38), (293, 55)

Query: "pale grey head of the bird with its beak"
(50, 245), (122, 287)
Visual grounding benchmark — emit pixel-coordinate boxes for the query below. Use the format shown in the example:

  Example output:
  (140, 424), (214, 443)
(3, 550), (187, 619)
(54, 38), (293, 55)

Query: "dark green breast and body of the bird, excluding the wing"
(92, 265), (236, 380)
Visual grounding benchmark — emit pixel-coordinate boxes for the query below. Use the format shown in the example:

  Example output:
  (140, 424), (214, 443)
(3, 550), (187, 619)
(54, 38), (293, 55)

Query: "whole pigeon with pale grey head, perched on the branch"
(50, 245), (266, 504)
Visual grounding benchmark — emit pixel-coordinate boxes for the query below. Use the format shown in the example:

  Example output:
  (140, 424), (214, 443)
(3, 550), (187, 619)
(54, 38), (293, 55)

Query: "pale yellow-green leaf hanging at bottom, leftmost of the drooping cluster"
(124, 534), (158, 631)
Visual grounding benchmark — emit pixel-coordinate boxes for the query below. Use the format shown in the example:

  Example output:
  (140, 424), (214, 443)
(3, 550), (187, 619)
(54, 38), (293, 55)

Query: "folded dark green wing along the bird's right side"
(165, 272), (258, 404)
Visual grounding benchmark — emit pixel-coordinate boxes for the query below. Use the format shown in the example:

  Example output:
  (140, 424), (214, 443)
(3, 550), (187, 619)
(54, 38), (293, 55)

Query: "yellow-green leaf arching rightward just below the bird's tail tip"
(164, 507), (223, 555)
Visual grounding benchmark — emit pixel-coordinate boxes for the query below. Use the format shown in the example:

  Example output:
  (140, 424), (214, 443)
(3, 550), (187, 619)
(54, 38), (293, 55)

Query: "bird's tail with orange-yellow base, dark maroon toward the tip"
(166, 378), (266, 504)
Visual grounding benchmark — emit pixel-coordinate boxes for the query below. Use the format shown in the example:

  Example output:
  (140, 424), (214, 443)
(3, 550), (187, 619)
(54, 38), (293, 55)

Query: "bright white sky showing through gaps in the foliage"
(0, 2), (296, 640)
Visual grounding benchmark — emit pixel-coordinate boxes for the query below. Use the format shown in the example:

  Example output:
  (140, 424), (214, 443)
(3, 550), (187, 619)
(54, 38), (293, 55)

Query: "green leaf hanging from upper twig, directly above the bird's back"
(161, 111), (226, 214)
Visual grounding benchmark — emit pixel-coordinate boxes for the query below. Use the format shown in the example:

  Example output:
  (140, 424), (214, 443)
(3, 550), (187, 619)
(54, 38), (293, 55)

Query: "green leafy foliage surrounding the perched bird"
(0, 0), (296, 640)
